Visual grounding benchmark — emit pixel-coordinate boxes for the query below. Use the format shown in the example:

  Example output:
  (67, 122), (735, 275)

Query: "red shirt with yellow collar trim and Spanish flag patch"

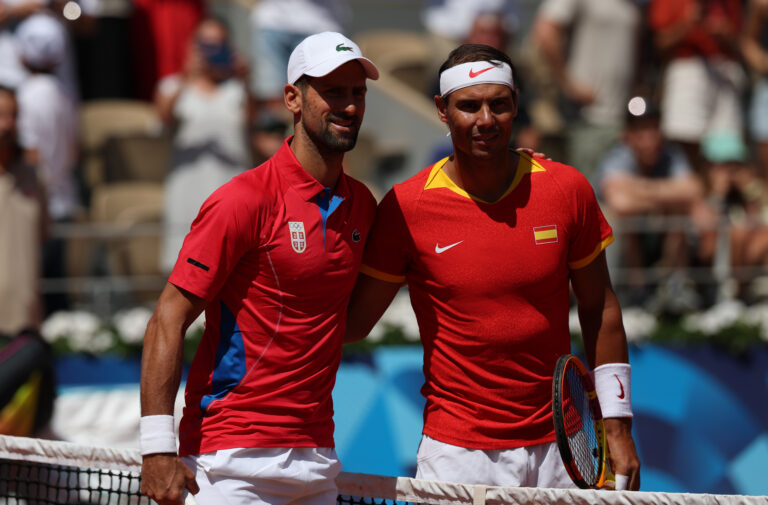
(362, 154), (612, 449)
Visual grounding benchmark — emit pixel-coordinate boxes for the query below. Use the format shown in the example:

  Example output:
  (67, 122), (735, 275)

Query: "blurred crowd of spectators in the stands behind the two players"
(0, 0), (768, 334)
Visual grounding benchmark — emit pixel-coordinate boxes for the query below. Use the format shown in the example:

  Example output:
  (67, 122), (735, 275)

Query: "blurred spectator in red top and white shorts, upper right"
(648, 0), (745, 173)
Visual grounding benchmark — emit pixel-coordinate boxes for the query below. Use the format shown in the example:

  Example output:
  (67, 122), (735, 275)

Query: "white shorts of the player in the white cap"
(183, 447), (341, 505)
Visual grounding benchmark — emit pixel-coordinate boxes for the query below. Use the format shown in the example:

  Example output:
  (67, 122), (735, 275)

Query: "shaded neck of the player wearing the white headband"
(443, 150), (520, 202)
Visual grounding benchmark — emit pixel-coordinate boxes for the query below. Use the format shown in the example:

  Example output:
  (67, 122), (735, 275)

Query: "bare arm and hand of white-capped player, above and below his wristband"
(141, 283), (206, 505)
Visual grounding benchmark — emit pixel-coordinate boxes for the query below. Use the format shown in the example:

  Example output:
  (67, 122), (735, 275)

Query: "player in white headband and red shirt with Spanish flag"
(346, 44), (640, 489)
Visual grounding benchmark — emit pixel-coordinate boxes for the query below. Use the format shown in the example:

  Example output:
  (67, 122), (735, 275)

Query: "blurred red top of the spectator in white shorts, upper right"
(648, 0), (743, 58)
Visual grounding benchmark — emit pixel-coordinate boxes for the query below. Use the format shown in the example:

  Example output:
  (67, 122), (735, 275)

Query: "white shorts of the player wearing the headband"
(416, 435), (576, 488)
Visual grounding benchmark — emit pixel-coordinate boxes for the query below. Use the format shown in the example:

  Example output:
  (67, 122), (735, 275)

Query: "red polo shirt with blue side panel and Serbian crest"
(169, 137), (376, 455)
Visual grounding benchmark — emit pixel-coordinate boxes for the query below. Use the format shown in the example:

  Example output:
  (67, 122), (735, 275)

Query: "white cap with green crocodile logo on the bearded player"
(288, 32), (379, 84)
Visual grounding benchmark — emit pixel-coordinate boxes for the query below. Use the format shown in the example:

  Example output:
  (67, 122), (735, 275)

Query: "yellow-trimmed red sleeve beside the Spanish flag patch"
(568, 170), (613, 270)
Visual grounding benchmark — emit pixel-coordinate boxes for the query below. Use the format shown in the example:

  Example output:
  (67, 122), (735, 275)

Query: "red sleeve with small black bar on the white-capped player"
(168, 183), (261, 301)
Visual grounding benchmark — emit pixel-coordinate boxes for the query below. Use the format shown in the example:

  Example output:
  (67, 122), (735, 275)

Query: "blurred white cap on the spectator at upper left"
(16, 14), (67, 68)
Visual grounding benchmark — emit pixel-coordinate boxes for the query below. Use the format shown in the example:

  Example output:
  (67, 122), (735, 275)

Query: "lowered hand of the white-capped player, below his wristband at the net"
(141, 454), (200, 505)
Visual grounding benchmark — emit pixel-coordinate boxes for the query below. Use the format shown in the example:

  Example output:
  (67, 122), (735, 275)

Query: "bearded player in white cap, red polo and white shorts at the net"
(140, 32), (378, 505)
